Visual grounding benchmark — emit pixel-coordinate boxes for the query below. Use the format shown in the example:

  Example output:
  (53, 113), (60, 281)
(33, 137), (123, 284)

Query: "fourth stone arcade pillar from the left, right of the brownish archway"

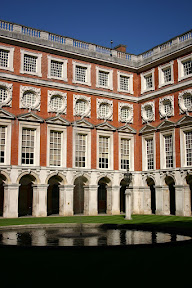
(88, 185), (98, 215)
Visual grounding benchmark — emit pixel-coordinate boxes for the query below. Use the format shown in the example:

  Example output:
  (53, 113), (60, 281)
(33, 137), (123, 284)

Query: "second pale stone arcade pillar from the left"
(32, 184), (49, 217)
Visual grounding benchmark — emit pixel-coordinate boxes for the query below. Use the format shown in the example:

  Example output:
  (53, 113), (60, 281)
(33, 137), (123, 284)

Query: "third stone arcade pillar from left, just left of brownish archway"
(59, 185), (75, 216)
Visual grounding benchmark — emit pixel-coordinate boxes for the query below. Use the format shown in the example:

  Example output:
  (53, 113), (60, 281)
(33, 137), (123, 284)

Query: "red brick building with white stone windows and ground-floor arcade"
(0, 21), (192, 217)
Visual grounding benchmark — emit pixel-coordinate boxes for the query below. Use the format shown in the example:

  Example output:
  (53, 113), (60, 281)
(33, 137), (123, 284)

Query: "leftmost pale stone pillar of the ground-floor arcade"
(3, 183), (20, 218)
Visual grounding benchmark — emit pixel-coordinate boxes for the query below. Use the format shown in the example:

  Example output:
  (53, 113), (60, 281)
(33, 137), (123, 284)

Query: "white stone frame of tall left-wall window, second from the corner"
(97, 130), (114, 170)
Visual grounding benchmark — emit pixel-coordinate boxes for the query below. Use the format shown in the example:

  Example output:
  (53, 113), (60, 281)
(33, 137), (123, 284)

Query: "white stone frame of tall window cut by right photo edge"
(180, 125), (192, 168)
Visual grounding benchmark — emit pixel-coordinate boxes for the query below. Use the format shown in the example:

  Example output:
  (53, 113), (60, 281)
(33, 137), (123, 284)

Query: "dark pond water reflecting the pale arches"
(0, 228), (191, 246)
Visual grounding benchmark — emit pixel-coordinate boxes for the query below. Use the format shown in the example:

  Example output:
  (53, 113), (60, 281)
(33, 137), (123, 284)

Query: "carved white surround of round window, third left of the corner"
(73, 94), (91, 118)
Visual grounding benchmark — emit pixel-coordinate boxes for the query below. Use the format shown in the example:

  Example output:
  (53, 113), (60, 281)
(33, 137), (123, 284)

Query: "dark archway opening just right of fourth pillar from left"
(98, 177), (110, 214)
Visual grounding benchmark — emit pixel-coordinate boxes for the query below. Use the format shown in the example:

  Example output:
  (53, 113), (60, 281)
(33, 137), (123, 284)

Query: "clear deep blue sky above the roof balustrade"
(0, 0), (192, 54)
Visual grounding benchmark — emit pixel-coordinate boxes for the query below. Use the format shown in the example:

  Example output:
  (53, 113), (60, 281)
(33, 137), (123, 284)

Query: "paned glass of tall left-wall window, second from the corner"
(99, 136), (109, 168)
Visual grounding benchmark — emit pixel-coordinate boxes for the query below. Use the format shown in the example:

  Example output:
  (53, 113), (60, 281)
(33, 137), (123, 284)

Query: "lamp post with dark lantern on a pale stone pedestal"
(124, 169), (132, 220)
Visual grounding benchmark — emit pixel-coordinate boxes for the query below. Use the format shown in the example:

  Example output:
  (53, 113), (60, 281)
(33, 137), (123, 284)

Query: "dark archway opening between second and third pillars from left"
(47, 175), (62, 216)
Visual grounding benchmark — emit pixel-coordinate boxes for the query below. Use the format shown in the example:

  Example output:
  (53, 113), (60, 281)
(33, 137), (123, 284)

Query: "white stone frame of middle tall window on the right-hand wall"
(160, 129), (176, 170)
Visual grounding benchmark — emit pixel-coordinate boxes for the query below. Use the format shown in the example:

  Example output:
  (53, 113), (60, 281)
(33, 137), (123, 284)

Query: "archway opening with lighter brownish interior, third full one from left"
(73, 176), (87, 214)
